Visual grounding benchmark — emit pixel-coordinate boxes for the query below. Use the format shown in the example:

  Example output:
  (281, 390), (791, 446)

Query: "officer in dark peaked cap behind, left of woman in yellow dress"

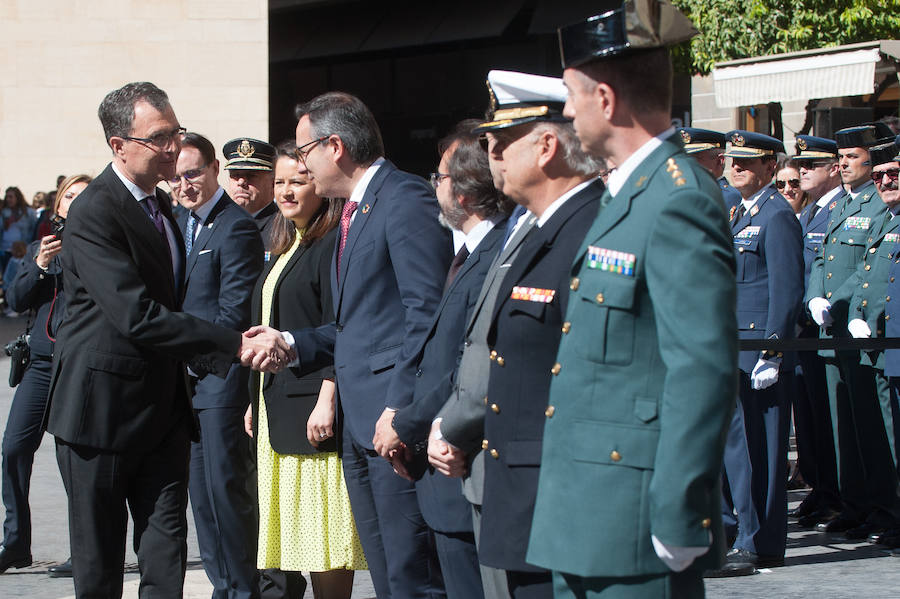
(222, 137), (278, 253)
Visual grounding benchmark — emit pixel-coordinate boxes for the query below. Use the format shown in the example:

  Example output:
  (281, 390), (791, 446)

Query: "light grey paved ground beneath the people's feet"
(0, 318), (900, 599)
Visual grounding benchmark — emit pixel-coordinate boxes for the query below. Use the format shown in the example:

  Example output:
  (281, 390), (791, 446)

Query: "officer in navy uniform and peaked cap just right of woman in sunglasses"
(789, 135), (844, 528)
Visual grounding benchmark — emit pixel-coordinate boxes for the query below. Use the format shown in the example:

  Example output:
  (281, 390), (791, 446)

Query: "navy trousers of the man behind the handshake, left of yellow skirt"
(190, 407), (259, 599)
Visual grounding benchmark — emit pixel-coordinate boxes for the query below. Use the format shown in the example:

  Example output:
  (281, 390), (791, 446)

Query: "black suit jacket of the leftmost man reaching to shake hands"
(47, 166), (240, 451)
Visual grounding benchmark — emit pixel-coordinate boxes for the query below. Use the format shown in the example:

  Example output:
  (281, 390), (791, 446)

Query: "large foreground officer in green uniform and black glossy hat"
(527, 1), (737, 599)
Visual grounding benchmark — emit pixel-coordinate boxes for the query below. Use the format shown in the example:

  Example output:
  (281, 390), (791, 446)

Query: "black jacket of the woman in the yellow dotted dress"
(250, 229), (337, 454)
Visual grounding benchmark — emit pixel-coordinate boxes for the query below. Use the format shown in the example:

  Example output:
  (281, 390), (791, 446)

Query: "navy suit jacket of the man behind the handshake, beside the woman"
(178, 194), (264, 409)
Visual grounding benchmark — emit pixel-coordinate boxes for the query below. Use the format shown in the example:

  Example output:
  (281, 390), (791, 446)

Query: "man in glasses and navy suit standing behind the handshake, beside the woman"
(170, 133), (264, 599)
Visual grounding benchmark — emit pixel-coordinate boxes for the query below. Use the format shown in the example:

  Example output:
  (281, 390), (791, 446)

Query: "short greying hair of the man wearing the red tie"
(295, 92), (384, 166)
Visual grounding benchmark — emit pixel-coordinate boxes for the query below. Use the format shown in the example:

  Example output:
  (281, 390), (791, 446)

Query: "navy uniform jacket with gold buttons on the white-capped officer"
(478, 181), (604, 571)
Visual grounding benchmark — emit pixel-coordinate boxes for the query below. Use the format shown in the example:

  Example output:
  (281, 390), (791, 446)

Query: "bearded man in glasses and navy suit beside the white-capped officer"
(373, 119), (512, 599)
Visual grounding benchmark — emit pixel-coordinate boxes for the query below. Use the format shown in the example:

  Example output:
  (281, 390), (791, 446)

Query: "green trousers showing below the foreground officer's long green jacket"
(553, 568), (704, 599)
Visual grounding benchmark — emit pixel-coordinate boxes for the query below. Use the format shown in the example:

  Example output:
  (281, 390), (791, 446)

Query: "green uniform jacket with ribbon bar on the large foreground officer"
(527, 136), (738, 577)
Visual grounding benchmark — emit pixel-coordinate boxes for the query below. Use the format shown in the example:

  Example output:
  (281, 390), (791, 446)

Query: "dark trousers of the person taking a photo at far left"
(2, 356), (51, 555)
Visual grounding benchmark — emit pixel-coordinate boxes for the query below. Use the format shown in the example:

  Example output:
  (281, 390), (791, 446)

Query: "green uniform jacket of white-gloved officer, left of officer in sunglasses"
(804, 182), (887, 356)
